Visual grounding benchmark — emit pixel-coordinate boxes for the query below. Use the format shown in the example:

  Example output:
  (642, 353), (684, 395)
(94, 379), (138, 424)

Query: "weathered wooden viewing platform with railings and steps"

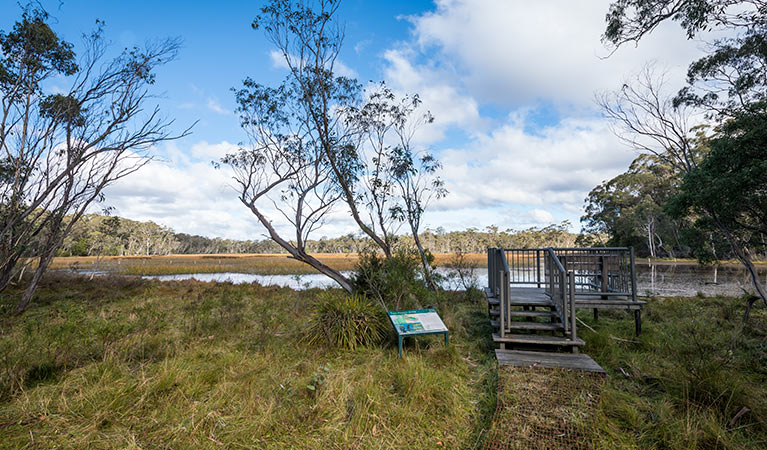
(485, 247), (645, 373)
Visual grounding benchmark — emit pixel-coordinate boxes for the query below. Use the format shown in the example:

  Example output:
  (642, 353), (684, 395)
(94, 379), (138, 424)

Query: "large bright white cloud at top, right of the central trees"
(409, 0), (712, 105)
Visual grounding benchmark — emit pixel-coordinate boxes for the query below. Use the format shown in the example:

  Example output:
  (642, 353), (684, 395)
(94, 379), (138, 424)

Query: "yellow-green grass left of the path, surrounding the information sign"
(0, 275), (495, 449)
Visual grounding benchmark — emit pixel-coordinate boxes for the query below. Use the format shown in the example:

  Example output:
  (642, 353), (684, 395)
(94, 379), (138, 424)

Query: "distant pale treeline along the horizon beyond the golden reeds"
(58, 214), (578, 256)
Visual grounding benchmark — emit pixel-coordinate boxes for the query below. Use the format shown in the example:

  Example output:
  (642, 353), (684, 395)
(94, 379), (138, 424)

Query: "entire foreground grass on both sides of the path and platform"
(0, 274), (767, 449)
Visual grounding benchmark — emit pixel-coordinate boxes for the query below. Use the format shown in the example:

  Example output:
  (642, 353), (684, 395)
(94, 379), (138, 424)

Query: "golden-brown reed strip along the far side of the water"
(45, 253), (487, 276)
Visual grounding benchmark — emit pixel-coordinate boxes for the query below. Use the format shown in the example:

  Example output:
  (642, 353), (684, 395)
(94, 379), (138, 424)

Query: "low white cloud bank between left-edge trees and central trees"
(99, 141), (366, 239)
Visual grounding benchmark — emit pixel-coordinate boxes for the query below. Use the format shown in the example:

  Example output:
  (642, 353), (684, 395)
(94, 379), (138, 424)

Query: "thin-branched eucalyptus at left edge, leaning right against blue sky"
(0, 7), (189, 313)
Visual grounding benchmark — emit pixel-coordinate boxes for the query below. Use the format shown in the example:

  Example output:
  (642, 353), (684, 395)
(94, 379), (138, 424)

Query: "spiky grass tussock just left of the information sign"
(306, 292), (388, 350)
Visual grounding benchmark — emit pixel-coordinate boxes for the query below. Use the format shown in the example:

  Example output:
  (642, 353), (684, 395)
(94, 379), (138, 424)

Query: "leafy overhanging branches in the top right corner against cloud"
(603, 0), (767, 117)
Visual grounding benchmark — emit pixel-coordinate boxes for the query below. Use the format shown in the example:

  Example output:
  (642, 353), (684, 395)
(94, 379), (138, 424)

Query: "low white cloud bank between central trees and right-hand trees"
(434, 114), (636, 226)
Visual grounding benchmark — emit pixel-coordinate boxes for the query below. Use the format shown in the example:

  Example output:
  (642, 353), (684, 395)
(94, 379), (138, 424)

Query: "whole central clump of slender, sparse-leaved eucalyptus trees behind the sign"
(222, 0), (448, 291)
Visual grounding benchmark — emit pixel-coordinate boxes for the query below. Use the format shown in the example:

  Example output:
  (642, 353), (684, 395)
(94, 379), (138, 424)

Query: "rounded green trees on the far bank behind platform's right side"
(579, 155), (767, 262)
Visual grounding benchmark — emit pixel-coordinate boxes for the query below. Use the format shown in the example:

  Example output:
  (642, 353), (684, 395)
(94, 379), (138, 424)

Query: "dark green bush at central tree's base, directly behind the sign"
(352, 248), (435, 310)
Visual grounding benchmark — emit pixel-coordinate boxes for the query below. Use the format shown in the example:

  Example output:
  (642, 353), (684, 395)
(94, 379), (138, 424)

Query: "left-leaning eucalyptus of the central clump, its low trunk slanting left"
(222, 0), (360, 291)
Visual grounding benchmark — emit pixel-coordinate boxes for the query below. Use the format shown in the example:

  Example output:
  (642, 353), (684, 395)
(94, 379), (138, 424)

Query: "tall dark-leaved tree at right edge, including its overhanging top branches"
(603, 0), (767, 312)
